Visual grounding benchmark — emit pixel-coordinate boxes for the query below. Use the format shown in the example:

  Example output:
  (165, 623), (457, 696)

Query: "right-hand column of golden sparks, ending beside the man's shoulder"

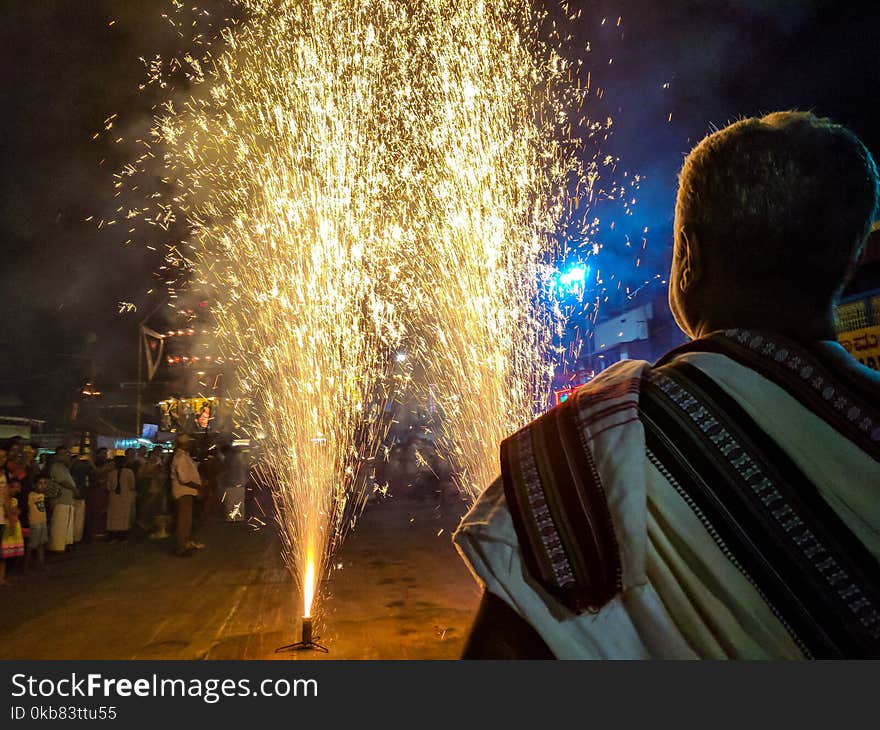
(396, 1), (584, 501)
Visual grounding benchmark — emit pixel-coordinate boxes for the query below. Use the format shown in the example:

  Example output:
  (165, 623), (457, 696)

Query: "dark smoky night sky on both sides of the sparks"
(0, 0), (880, 417)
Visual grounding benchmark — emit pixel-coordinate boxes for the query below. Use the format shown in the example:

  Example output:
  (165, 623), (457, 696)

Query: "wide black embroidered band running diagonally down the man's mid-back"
(642, 363), (880, 656)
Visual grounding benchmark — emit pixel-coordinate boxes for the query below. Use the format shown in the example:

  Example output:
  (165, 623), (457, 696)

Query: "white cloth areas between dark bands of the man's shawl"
(455, 343), (880, 659)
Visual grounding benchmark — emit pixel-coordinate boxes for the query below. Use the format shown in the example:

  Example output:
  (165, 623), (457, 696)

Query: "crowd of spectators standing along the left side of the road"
(0, 435), (253, 586)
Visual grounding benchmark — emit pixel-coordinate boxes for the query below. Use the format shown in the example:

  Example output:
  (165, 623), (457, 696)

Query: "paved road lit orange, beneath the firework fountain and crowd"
(0, 498), (479, 659)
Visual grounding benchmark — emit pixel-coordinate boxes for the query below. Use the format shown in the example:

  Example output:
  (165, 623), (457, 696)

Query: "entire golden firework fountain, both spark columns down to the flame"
(118, 0), (582, 628)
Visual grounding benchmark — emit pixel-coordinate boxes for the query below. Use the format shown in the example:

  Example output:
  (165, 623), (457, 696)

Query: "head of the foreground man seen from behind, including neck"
(669, 112), (878, 337)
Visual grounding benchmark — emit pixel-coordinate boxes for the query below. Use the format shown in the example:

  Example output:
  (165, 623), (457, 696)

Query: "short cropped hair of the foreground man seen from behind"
(675, 112), (880, 305)
